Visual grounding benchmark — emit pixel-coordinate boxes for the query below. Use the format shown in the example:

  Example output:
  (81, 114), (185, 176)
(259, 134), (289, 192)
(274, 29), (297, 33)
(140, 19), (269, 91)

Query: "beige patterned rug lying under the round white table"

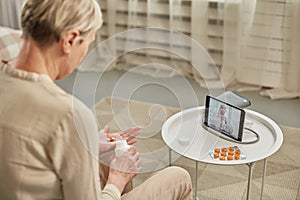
(95, 91), (300, 200)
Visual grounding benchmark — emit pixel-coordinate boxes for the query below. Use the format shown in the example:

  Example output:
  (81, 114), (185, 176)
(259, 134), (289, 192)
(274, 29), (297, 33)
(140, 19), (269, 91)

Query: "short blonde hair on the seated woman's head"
(21, 0), (103, 46)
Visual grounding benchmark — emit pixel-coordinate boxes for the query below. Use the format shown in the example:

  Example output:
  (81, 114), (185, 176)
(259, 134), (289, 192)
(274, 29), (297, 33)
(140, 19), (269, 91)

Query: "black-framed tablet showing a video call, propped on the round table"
(203, 95), (245, 141)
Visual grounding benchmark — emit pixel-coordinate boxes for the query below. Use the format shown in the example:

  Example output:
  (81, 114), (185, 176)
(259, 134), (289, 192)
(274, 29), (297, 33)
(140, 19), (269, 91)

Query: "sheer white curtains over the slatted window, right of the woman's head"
(87, 0), (300, 99)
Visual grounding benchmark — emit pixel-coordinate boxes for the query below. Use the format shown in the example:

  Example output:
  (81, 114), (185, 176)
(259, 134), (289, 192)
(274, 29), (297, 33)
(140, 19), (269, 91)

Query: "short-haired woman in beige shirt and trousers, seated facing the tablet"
(0, 0), (192, 200)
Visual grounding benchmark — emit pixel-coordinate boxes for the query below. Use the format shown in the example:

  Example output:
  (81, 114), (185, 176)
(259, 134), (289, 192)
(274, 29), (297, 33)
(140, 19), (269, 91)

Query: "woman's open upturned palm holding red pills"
(99, 126), (141, 153)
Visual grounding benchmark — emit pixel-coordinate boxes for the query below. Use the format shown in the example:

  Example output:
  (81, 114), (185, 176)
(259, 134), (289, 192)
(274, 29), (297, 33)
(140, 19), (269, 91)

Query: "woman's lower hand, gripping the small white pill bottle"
(107, 146), (141, 193)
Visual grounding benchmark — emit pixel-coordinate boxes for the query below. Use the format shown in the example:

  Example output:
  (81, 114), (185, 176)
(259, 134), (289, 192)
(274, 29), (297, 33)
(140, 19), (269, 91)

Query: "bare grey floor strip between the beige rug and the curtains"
(57, 70), (300, 128)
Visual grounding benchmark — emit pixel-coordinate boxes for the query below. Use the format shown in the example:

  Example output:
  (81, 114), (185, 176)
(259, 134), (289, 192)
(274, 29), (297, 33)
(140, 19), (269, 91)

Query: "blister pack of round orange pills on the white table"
(209, 146), (246, 161)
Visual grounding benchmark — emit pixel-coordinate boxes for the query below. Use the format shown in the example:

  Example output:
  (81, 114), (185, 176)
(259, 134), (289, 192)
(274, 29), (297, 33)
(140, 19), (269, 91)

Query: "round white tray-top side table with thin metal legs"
(161, 106), (283, 200)
